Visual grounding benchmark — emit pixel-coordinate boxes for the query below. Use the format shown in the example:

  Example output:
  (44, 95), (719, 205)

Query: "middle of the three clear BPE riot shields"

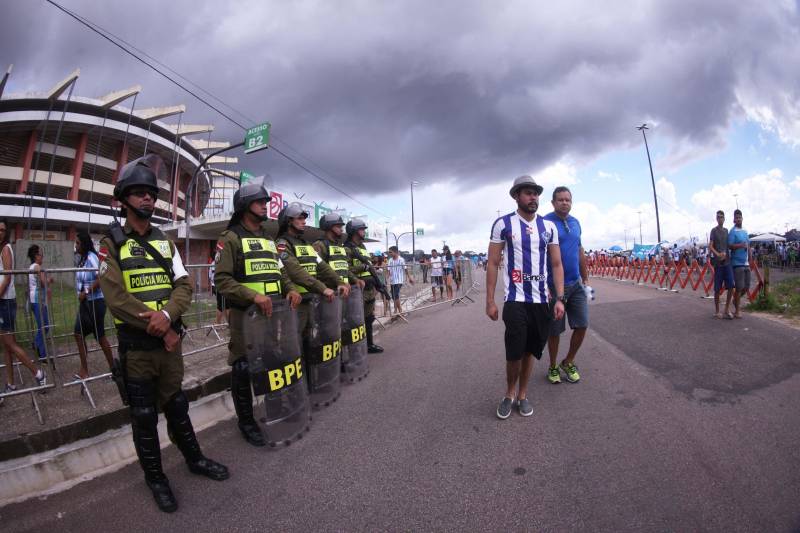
(303, 295), (342, 409)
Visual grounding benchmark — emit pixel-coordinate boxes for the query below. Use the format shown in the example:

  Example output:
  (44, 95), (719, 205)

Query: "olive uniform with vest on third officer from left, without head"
(275, 233), (345, 337)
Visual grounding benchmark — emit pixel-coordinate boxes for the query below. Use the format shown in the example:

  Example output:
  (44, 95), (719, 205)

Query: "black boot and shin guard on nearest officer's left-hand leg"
(126, 379), (178, 513)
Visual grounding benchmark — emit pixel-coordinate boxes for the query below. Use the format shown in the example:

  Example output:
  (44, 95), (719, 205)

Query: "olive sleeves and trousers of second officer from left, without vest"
(214, 224), (298, 365)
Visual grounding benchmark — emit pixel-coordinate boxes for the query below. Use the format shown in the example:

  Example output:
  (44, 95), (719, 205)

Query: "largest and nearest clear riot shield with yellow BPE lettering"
(236, 300), (311, 446)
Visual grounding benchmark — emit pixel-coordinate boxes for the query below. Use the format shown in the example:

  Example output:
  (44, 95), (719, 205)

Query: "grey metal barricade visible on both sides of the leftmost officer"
(0, 265), (227, 423)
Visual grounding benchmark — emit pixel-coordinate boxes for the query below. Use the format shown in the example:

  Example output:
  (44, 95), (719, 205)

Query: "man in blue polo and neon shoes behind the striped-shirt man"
(544, 186), (589, 384)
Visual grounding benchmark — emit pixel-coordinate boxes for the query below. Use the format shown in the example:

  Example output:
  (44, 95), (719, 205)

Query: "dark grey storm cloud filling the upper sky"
(0, 0), (800, 198)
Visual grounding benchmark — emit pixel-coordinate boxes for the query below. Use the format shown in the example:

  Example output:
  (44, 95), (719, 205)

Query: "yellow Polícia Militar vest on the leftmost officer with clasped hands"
(114, 229), (172, 325)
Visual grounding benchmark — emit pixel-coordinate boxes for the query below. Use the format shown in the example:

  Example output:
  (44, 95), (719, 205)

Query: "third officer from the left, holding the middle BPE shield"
(275, 203), (350, 337)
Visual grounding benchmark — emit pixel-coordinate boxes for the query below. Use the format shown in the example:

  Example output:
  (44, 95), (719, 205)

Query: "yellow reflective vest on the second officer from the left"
(234, 236), (281, 296)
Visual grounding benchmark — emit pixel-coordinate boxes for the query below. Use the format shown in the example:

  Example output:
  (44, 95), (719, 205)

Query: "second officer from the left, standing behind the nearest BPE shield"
(214, 183), (301, 446)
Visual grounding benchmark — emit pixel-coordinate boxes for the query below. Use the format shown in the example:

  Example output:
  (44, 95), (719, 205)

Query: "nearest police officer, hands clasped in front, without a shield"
(99, 154), (228, 513)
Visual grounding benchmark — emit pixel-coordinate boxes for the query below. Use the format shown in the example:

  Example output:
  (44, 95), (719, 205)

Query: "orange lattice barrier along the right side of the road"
(586, 257), (764, 302)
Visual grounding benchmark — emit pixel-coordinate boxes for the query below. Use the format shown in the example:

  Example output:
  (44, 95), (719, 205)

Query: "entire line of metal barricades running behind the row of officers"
(0, 259), (478, 424)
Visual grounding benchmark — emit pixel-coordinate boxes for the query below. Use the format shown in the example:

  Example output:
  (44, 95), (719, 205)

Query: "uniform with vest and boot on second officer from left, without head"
(214, 223), (302, 446)
